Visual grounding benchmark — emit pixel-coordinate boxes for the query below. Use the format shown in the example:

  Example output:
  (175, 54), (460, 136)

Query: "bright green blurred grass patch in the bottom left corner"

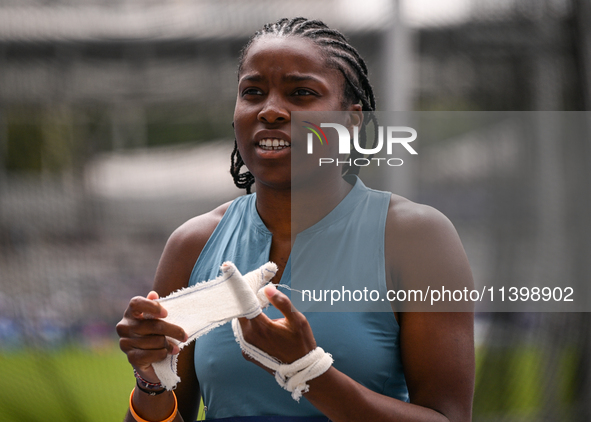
(0, 347), (134, 422)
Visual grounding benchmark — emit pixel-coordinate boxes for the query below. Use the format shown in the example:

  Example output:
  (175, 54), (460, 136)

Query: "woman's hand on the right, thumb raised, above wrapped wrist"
(239, 285), (316, 373)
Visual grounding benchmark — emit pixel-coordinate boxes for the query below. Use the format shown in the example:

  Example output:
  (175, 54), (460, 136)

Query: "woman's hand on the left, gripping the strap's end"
(117, 291), (188, 383)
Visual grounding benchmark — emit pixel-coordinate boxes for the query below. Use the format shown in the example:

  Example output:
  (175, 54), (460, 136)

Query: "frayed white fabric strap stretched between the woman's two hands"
(152, 262), (277, 390)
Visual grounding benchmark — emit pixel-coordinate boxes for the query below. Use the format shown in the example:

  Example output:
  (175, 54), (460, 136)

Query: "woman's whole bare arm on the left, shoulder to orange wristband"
(117, 204), (229, 422)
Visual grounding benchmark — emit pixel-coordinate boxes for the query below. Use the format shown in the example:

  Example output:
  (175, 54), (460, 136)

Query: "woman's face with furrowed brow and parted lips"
(234, 35), (360, 188)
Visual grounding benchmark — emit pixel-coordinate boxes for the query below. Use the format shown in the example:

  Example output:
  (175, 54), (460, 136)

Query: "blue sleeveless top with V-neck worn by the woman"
(189, 177), (408, 419)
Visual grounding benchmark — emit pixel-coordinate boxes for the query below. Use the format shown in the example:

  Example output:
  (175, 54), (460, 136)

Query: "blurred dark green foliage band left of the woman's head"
(0, 104), (233, 174)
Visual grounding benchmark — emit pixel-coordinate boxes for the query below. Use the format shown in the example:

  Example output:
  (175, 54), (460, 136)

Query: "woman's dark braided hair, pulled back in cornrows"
(230, 17), (378, 194)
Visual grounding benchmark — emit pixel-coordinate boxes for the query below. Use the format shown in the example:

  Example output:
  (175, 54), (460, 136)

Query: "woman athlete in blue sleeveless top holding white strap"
(117, 18), (474, 422)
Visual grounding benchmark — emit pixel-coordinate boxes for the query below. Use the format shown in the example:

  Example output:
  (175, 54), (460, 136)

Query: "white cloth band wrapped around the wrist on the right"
(232, 319), (333, 402)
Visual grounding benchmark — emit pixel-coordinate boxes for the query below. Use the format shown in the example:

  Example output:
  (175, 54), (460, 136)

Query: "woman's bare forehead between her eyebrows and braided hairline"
(239, 35), (339, 77)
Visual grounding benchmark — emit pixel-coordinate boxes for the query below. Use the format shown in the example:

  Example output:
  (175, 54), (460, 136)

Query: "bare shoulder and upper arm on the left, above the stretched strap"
(154, 201), (232, 297)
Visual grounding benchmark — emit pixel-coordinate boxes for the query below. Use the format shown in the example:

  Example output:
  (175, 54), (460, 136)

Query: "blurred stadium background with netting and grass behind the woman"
(0, 0), (591, 422)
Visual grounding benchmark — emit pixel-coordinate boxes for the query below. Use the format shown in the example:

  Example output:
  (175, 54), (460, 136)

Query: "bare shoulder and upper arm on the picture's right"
(386, 198), (475, 422)
